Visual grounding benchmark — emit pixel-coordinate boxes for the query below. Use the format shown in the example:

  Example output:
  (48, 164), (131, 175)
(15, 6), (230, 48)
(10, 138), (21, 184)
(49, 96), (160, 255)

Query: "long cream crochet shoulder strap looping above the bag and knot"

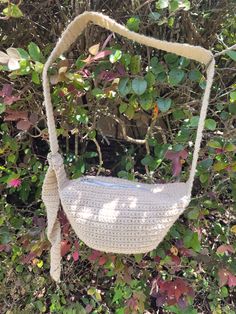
(43, 12), (215, 193)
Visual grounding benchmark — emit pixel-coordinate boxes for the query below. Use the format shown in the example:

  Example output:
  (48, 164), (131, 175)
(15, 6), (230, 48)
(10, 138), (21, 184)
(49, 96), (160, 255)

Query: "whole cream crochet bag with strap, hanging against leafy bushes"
(42, 12), (215, 281)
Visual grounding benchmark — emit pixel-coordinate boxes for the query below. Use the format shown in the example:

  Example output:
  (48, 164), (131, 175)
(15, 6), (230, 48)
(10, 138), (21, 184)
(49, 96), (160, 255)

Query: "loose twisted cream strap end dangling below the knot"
(42, 163), (61, 282)
